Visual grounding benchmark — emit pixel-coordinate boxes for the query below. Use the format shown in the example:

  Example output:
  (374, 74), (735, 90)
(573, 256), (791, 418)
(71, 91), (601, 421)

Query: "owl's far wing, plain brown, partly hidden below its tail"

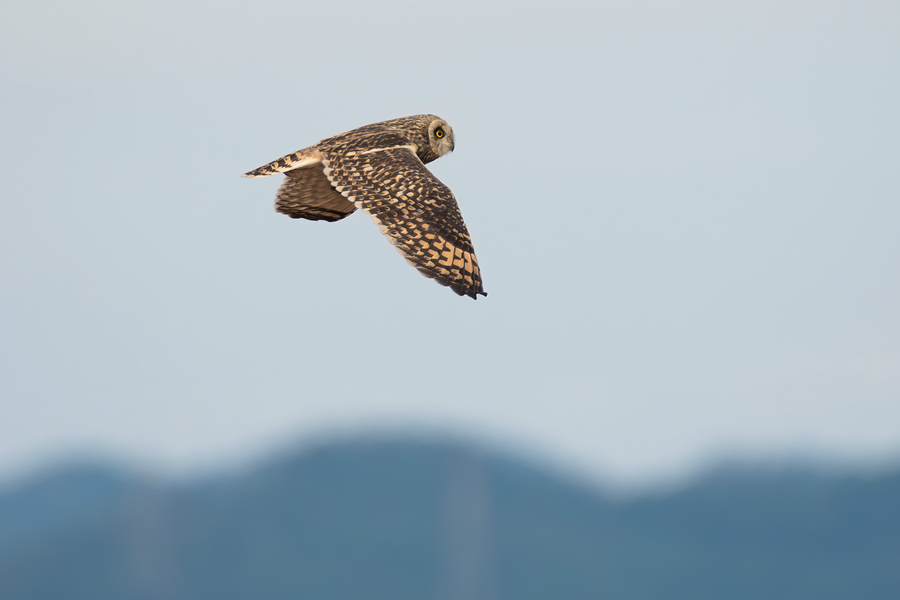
(275, 163), (356, 221)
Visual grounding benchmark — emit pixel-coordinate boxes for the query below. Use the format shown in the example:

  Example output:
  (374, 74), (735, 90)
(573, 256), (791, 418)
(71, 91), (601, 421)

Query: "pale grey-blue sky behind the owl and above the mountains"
(0, 0), (900, 483)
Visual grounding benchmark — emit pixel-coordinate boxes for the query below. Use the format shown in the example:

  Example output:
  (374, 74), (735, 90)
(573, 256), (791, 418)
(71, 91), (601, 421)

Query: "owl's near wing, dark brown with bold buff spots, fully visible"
(322, 146), (487, 298)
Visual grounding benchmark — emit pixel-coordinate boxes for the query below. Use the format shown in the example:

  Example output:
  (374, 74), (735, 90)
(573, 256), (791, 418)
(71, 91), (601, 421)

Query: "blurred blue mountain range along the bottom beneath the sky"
(0, 440), (900, 600)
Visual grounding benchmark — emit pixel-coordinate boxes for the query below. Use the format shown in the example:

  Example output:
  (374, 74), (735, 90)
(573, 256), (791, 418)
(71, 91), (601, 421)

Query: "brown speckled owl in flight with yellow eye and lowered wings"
(244, 115), (487, 298)
